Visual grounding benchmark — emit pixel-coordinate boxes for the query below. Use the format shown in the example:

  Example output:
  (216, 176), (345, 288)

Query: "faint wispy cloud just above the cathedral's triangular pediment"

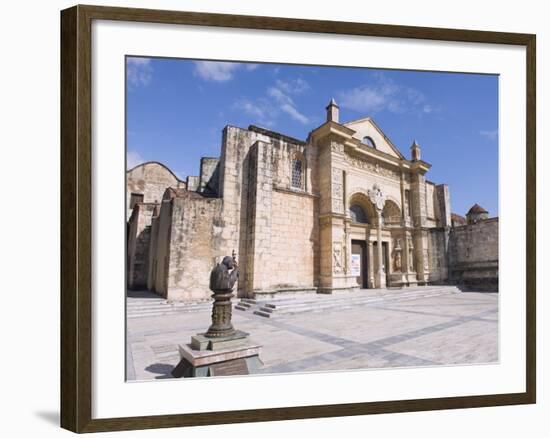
(338, 73), (438, 114)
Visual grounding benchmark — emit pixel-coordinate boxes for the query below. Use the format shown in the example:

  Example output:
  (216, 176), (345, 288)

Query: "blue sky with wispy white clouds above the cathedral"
(126, 58), (498, 216)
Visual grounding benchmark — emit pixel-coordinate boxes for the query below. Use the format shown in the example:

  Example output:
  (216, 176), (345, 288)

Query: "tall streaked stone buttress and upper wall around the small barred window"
(219, 126), (315, 296)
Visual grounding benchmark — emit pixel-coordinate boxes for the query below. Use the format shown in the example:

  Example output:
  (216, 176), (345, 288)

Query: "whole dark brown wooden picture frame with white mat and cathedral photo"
(61, 6), (536, 432)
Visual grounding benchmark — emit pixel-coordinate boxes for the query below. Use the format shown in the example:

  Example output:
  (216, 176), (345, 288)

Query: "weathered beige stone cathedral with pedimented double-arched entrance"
(126, 100), (498, 301)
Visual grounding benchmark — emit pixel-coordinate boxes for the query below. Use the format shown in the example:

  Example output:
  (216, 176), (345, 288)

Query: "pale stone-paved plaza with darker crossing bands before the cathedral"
(127, 290), (498, 380)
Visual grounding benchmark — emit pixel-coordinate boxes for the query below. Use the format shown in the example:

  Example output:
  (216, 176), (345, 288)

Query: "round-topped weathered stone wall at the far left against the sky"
(126, 161), (186, 220)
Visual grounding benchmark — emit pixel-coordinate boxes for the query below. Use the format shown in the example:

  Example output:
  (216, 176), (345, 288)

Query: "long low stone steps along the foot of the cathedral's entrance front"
(235, 286), (460, 318)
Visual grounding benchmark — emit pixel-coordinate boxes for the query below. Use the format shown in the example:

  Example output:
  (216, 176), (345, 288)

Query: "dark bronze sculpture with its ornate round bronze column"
(204, 251), (239, 338)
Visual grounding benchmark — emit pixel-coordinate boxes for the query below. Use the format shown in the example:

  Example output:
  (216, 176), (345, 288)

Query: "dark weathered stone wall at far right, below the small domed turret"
(449, 218), (498, 290)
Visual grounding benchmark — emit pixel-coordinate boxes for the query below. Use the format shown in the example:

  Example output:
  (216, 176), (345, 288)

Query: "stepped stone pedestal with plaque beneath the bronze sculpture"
(172, 330), (263, 378)
